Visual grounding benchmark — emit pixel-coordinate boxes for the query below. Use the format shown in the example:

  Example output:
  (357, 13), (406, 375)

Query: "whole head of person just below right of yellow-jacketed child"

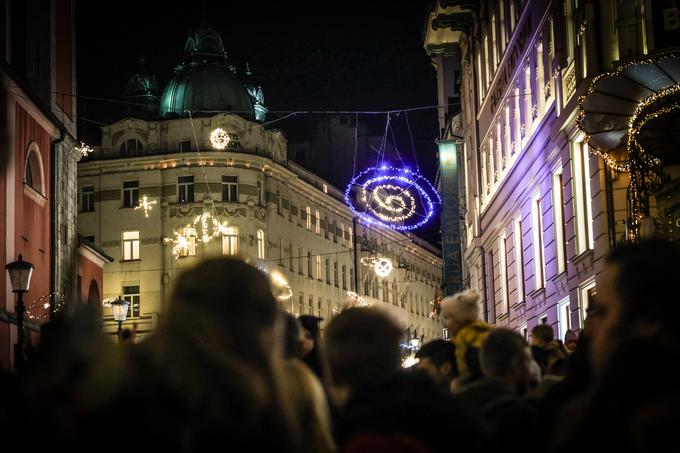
(479, 329), (532, 394)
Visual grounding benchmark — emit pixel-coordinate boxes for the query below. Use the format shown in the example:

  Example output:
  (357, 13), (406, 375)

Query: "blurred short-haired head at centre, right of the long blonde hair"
(325, 307), (403, 406)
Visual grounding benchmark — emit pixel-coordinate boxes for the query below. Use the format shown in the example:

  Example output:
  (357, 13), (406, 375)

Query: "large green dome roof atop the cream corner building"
(159, 26), (255, 120)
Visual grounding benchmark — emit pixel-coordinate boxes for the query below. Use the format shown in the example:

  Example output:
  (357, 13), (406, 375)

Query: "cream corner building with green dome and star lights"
(78, 25), (442, 340)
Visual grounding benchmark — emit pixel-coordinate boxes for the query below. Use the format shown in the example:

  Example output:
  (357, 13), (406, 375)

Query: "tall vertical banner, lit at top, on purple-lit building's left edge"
(439, 140), (463, 296)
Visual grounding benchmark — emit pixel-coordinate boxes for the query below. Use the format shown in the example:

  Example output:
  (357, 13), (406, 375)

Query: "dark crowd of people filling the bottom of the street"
(0, 241), (680, 453)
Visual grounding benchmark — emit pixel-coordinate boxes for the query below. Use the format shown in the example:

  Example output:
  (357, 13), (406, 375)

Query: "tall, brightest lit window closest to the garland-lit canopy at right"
(571, 142), (595, 255)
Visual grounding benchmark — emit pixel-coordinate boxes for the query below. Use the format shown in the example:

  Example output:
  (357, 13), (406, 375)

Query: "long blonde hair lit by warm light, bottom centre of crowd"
(283, 359), (337, 453)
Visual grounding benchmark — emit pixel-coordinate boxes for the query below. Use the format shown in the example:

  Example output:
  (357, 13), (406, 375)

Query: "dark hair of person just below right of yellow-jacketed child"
(479, 329), (528, 378)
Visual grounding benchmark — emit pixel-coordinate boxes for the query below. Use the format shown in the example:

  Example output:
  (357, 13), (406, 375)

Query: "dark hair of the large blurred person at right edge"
(606, 240), (680, 339)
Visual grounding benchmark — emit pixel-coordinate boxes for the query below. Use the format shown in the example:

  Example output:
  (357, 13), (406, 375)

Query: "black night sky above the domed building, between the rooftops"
(76, 0), (438, 244)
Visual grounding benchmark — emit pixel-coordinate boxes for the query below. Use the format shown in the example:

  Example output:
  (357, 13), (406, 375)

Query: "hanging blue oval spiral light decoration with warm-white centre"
(345, 165), (441, 231)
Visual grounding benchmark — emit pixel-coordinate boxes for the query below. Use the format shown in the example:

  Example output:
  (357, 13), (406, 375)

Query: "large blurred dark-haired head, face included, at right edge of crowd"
(591, 240), (680, 364)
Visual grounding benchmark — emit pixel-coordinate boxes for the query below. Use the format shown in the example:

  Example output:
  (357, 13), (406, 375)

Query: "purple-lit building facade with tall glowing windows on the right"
(424, 0), (679, 338)
